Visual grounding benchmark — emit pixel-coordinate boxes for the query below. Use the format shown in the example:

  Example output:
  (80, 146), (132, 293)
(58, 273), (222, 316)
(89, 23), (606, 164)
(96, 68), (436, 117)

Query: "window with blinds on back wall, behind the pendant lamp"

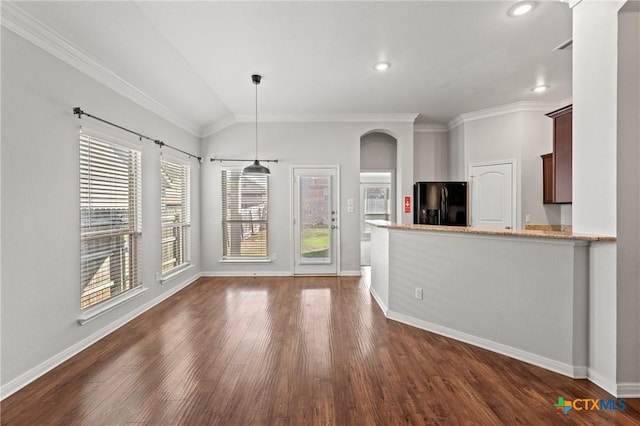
(222, 170), (269, 260)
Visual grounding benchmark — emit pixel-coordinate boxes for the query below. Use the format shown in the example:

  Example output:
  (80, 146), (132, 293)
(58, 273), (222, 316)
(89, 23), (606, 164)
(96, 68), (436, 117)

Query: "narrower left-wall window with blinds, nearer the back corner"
(160, 159), (191, 274)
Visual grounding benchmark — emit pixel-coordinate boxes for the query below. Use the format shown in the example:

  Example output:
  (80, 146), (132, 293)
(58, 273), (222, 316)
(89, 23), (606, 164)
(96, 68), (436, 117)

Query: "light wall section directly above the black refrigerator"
(413, 126), (449, 182)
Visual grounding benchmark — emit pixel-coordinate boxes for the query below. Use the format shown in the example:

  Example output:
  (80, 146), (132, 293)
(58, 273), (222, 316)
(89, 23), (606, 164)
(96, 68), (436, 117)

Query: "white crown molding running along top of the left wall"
(2, 1), (200, 136)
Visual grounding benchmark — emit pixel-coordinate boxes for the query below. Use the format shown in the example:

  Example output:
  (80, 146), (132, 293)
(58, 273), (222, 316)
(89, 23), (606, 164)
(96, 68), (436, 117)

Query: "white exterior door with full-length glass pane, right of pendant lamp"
(293, 167), (340, 275)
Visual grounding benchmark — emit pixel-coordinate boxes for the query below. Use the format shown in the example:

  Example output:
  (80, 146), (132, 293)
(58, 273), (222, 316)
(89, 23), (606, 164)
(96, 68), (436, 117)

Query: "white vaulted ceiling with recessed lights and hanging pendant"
(8, 1), (571, 135)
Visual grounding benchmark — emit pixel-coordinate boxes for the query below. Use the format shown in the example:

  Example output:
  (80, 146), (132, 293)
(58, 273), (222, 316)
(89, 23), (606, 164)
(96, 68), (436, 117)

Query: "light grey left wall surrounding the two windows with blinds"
(1, 28), (200, 395)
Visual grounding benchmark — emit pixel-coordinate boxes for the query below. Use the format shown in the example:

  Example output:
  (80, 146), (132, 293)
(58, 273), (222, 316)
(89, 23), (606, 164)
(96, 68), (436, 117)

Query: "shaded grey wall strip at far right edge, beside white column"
(616, 2), (640, 392)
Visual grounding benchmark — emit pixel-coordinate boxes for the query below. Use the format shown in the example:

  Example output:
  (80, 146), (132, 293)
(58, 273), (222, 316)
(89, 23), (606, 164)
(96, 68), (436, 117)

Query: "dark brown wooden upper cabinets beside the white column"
(543, 105), (573, 204)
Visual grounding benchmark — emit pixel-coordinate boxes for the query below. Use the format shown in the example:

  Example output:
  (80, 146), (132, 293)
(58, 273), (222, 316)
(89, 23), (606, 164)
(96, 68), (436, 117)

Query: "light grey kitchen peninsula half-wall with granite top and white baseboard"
(368, 221), (615, 378)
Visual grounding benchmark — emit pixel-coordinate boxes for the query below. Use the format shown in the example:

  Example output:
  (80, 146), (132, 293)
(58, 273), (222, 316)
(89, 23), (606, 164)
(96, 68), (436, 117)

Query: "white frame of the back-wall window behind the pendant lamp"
(220, 167), (271, 263)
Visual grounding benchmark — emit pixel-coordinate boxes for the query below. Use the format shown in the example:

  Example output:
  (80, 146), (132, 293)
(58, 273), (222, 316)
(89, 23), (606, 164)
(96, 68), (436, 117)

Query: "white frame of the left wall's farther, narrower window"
(160, 153), (192, 280)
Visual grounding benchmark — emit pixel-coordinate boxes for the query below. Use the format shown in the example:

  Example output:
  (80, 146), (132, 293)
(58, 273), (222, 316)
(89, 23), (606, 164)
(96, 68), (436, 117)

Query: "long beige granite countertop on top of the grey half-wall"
(367, 220), (616, 241)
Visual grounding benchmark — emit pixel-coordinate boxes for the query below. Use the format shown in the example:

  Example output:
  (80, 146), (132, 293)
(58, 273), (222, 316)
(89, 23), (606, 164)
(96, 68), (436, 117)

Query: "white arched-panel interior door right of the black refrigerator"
(469, 162), (516, 229)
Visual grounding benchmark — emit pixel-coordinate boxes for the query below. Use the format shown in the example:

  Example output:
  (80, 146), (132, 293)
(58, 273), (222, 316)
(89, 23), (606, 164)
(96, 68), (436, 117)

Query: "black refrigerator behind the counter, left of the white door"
(413, 182), (469, 226)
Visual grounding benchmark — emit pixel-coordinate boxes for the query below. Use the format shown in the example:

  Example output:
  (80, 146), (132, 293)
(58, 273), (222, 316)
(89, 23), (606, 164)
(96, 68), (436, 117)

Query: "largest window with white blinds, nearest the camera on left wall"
(80, 134), (142, 310)
